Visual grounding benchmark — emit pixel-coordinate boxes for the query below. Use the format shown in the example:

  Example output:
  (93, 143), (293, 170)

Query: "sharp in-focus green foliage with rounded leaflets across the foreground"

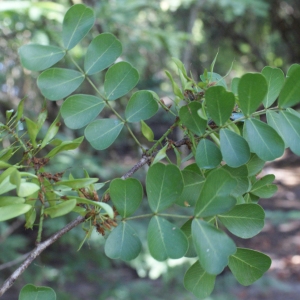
(0, 4), (300, 299)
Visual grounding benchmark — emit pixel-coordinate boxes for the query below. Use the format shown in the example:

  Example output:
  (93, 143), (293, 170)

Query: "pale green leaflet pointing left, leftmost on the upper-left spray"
(19, 44), (66, 71)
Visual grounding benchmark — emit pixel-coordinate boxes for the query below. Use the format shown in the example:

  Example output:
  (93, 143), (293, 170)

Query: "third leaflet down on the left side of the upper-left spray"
(61, 94), (105, 129)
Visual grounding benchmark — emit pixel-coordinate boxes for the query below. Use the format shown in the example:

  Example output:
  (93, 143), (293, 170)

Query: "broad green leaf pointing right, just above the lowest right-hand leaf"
(218, 204), (265, 239)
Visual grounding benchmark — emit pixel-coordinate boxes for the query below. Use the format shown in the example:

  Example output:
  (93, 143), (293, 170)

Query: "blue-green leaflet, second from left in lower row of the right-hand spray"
(220, 129), (250, 168)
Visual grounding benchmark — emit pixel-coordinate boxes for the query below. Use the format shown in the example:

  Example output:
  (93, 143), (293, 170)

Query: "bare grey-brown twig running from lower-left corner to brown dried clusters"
(0, 217), (85, 297)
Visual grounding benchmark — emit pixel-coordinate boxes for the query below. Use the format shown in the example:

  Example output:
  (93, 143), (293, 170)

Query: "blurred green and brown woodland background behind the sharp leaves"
(0, 0), (300, 300)
